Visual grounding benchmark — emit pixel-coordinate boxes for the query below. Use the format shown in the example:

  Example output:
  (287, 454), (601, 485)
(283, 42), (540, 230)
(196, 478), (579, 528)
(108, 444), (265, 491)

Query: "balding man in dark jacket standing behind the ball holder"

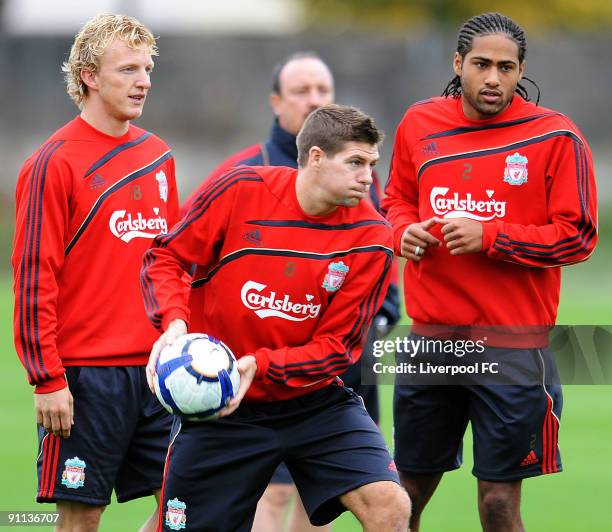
(181, 51), (399, 532)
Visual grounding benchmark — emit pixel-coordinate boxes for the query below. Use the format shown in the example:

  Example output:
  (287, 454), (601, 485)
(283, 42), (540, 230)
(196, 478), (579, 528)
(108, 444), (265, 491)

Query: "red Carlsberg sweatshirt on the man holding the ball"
(141, 166), (393, 401)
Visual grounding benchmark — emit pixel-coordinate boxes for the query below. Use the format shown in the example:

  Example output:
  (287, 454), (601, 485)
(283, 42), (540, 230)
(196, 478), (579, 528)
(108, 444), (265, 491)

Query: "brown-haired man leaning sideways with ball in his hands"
(141, 105), (410, 532)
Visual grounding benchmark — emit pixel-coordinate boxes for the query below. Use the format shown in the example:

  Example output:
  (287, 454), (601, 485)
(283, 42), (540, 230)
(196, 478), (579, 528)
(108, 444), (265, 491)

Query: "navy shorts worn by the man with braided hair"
(393, 347), (563, 482)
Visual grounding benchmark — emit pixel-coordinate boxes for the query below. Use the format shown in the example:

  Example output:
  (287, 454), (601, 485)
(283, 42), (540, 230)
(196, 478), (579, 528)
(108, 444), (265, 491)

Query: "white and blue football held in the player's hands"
(154, 333), (240, 421)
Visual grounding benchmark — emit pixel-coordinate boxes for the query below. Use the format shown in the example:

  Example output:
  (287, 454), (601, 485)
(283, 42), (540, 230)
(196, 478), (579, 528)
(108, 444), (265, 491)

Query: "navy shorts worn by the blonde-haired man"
(36, 366), (172, 506)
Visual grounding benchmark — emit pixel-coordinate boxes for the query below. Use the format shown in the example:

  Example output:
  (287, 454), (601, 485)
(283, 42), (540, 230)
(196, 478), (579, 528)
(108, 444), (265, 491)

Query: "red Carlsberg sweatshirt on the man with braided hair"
(383, 96), (597, 347)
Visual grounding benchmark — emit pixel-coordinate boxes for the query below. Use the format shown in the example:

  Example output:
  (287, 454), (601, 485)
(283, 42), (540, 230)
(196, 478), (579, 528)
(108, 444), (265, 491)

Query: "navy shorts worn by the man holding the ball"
(160, 385), (399, 532)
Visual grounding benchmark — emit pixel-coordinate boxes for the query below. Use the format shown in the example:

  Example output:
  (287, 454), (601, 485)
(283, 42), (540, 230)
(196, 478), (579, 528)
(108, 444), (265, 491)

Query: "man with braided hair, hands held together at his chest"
(383, 13), (597, 531)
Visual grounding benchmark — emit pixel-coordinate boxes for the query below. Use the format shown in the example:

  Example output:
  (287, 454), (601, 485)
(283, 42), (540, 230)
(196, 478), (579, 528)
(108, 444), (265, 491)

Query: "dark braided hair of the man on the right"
(442, 13), (540, 105)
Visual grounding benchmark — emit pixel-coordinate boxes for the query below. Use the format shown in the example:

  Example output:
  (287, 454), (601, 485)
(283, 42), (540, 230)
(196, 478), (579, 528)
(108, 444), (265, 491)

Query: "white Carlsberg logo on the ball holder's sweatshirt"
(240, 281), (321, 321)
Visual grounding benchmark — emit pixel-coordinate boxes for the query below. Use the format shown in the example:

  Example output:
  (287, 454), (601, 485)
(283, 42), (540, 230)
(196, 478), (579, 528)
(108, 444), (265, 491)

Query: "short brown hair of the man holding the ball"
(297, 104), (384, 168)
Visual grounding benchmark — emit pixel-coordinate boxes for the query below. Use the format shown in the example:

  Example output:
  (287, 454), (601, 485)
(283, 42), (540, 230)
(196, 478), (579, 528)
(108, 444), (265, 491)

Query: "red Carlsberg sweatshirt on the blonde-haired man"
(12, 117), (178, 393)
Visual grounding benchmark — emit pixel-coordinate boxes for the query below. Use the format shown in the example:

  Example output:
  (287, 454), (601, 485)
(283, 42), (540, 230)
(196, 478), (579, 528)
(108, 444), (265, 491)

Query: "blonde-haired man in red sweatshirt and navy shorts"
(12, 13), (178, 531)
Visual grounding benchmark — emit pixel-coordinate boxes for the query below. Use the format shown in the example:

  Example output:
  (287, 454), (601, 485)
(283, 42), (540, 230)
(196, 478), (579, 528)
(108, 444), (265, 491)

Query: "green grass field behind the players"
(0, 253), (612, 532)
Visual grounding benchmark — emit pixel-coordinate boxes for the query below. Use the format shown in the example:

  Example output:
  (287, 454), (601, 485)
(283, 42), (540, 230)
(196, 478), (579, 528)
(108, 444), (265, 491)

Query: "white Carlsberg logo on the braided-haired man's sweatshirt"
(429, 187), (506, 222)
